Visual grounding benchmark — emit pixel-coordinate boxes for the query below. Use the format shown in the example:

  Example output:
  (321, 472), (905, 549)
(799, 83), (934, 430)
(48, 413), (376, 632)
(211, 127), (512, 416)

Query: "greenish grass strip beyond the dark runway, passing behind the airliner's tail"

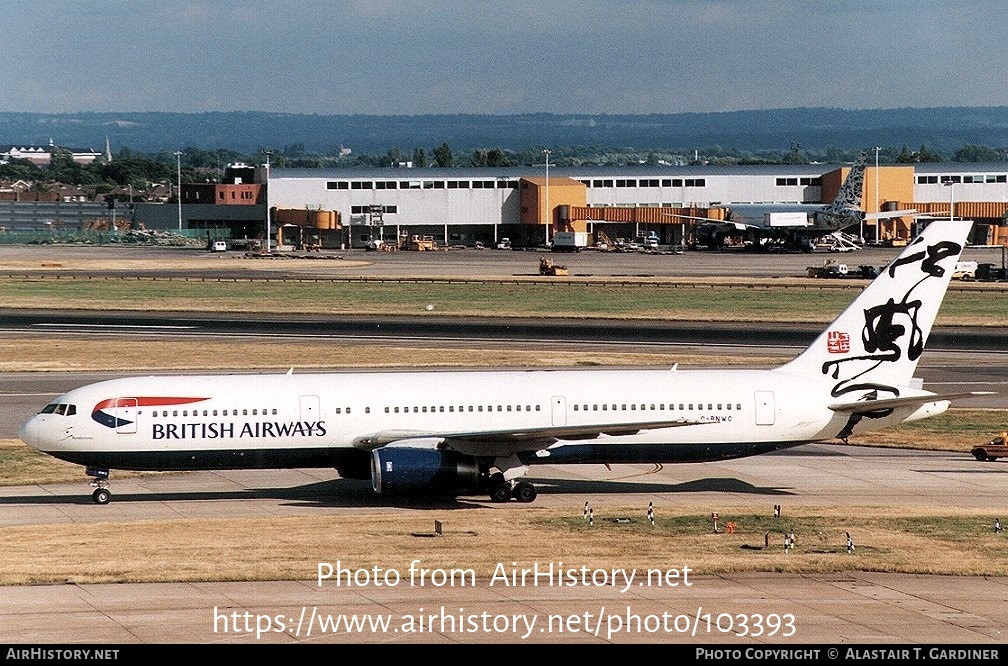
(0, 278), (1008, 326)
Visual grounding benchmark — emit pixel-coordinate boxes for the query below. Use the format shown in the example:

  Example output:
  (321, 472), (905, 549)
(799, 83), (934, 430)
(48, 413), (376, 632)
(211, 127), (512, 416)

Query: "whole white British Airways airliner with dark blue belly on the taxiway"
(20, 221), (980, 504)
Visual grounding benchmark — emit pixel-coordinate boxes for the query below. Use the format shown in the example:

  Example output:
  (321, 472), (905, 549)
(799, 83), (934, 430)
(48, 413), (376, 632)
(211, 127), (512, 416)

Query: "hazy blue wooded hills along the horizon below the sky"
(0, 107), (1008, 155)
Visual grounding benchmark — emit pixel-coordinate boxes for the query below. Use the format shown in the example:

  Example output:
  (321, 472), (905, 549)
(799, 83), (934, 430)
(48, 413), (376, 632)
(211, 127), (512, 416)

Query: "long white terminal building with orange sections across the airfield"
(137, 163), (1008, 249)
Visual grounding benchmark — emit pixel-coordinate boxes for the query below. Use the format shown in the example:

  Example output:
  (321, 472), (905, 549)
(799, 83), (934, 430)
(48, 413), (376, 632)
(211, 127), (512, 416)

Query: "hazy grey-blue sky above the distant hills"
(0, 0), (1008, 115)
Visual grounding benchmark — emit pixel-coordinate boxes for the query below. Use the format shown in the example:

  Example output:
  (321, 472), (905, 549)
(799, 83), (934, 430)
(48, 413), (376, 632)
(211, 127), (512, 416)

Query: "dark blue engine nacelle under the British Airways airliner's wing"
(371, 446), (480, 495)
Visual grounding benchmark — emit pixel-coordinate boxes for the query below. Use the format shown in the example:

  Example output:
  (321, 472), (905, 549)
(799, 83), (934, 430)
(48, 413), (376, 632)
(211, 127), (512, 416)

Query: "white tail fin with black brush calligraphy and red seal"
(780, 220), (973, 397)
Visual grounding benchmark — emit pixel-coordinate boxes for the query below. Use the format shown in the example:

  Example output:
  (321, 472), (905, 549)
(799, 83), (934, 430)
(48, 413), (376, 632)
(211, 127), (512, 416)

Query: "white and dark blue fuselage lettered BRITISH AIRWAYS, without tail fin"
(21, 362), (923, 476)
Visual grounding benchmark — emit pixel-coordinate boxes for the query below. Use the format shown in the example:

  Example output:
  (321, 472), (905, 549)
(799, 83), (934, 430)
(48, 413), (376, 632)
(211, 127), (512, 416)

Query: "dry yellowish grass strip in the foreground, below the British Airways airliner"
(0, 504), (1008, 584)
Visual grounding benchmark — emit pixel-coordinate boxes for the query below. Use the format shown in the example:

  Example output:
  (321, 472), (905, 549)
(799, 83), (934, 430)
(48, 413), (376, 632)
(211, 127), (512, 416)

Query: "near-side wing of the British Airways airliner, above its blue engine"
(354, 418), (712, 455)
